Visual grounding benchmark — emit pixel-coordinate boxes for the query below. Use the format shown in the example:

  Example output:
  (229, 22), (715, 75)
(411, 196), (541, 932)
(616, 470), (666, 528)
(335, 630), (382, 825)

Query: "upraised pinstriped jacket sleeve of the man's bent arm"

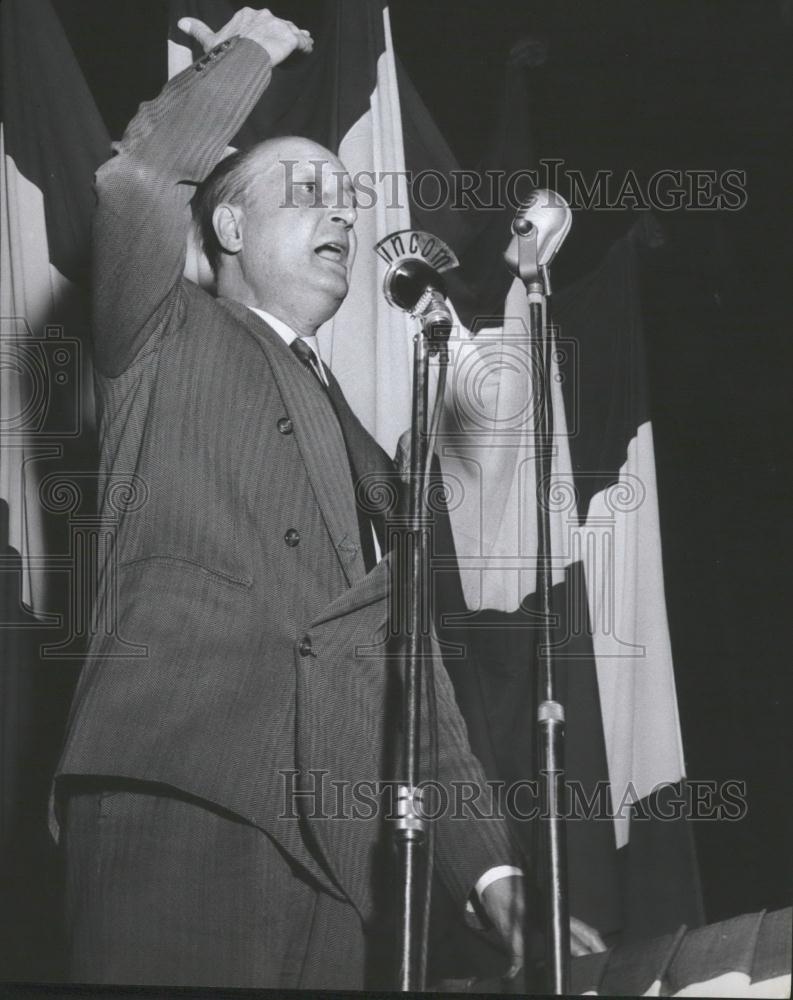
(92, 36), (272, 377)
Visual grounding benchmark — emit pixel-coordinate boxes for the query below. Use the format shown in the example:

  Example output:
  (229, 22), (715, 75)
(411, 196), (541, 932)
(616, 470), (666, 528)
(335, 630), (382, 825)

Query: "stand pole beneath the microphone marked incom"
(393, 315), (448, 992)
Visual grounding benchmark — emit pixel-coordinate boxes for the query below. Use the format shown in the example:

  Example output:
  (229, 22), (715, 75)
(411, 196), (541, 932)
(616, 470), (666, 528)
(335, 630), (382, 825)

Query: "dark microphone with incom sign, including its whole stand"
(376, 238), (457, 992)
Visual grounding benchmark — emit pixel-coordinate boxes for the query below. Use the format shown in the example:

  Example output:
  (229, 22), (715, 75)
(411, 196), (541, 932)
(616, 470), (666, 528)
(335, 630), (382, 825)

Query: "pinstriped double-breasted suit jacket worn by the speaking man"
(58, 31), (513, 918)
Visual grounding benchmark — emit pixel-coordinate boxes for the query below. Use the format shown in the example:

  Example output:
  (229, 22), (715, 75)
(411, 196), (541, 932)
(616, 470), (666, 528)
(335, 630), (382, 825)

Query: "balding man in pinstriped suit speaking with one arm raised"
(55, 8), (599, 988)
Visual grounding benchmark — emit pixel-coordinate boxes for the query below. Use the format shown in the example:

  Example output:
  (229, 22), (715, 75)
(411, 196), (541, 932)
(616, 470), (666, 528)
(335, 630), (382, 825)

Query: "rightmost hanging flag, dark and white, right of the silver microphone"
(555, 232), (703, 937)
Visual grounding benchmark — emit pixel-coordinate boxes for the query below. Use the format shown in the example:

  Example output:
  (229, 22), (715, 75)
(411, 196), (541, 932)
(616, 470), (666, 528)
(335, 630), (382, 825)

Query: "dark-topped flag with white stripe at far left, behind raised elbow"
(0, 0), (109, 615)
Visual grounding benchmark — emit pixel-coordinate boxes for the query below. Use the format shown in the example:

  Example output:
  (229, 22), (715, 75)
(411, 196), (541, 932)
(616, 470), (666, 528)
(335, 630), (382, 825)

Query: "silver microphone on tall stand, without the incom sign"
(504, 191), (572, 996)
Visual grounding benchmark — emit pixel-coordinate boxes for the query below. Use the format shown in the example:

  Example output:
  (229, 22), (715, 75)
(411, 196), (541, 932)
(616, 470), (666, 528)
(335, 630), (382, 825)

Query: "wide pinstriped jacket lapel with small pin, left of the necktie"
(217, 299), (365, 584)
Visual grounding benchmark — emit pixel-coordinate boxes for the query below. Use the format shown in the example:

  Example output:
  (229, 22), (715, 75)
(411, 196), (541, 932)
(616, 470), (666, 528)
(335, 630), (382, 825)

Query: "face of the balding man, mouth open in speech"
(239, 138), (357, 326)
